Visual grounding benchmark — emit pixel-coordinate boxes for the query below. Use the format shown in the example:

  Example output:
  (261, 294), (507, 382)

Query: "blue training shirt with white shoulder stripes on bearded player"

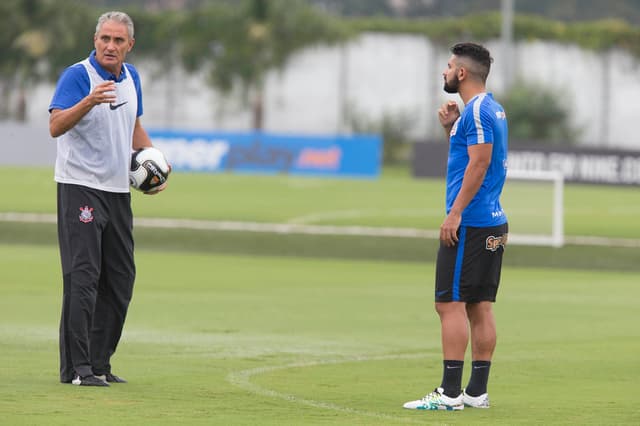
(447, 93), (508, 227)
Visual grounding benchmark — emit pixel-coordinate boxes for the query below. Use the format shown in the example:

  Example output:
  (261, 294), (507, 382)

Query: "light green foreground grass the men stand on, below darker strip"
(0, 245), (640, 425)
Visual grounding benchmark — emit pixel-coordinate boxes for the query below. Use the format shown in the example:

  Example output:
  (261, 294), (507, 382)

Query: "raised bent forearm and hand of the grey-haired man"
(49, 81), (116, 138)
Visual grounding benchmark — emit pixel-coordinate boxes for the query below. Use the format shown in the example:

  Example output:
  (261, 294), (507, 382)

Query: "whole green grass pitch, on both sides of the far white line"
(0, 168), (640, 425)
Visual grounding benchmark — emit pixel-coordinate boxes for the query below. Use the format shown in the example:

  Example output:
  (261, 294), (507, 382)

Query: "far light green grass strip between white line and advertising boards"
(0, 168), (640, 239)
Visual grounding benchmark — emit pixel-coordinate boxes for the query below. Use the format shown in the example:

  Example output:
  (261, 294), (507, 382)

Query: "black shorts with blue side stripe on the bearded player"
(435, 223), (509, 303)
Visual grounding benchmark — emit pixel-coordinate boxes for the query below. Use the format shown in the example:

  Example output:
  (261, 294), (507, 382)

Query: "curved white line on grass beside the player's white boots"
(227, 354), (429, 423)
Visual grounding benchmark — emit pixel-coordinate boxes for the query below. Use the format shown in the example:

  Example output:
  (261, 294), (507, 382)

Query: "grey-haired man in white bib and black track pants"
(49, 12), (164, 386)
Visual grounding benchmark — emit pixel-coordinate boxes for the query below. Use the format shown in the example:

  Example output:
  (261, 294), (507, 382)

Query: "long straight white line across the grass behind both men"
(0, 212), (640, 248)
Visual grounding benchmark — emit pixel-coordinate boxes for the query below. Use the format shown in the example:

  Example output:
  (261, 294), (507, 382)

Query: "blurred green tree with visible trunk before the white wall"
(180, 0), (346, 130)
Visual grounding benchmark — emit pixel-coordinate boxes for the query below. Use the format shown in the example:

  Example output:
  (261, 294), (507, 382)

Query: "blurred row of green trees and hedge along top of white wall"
(5, 0), (640, 129)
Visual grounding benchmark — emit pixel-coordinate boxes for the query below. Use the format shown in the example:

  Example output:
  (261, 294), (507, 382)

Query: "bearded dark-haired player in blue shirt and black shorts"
(404, 43), (508, 410)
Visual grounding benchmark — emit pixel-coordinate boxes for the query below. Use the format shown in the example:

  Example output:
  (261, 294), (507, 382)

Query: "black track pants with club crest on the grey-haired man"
(58, 183), (135, 382)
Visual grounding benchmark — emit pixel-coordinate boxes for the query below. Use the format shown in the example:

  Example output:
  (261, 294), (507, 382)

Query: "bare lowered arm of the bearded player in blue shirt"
(440, 143), (493, 247)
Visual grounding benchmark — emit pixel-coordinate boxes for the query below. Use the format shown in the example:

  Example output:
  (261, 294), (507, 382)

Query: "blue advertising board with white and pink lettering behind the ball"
(149, 130), (382, 178)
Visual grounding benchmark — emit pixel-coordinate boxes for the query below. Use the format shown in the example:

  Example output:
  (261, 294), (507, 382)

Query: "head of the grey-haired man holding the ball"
(93, 21), (134, 75)
